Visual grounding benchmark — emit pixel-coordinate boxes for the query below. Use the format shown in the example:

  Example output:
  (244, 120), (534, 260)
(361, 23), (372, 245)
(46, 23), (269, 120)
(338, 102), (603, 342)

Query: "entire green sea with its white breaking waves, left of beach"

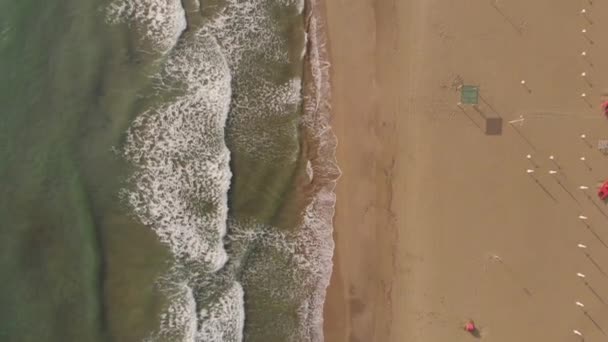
(0, 0), (339, 342)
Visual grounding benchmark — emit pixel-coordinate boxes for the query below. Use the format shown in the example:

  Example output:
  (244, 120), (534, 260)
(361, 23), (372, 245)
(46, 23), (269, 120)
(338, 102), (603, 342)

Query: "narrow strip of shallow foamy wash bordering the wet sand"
(303, 0), (341, 342)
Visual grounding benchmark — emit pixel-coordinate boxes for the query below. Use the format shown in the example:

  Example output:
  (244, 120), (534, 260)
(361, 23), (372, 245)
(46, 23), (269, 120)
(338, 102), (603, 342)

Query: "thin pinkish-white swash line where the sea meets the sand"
(302, 0), (341, 342)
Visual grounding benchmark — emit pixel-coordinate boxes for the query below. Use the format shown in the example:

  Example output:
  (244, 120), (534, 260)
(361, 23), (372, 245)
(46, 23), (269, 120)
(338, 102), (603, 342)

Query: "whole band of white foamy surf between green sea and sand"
(105, 0), (339, 342)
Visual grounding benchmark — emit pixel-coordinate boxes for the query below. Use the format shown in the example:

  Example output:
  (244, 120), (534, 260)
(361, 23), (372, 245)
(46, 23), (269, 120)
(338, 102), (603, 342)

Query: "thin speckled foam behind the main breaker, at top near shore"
(204, 0), (302, 163)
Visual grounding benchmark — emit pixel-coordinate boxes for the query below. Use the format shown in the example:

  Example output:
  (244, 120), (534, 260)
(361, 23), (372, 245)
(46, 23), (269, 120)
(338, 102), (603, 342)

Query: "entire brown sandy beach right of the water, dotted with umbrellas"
(325, 0), (608, 342)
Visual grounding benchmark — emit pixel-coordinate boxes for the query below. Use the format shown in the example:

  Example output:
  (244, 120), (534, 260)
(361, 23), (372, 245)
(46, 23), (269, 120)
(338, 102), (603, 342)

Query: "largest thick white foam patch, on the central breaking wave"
(125, 30), (231, 270)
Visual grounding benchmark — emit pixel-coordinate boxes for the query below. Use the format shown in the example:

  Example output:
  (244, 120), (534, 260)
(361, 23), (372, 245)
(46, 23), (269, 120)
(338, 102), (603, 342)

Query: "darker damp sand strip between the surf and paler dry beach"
(324, 1), (406, 342)
